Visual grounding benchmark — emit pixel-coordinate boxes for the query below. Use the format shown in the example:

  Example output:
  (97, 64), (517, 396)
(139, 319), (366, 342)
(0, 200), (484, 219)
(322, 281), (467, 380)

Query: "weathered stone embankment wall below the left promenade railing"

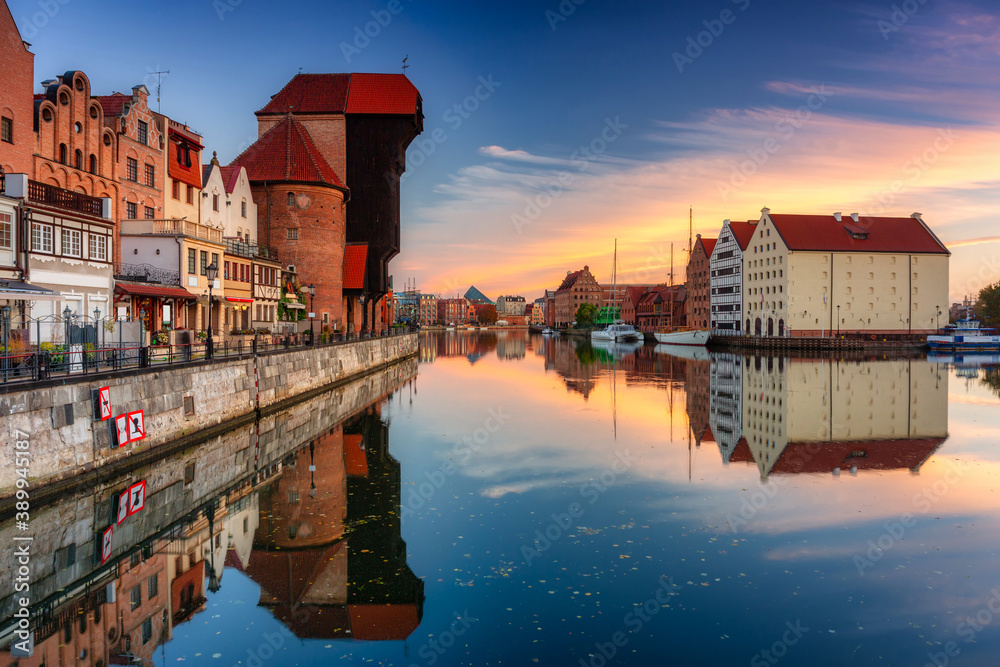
(0, 334), (418, 498)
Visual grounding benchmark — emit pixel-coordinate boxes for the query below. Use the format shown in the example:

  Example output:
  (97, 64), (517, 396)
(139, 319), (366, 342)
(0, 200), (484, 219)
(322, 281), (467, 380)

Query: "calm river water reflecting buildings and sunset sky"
(0, 332), (1000, 667)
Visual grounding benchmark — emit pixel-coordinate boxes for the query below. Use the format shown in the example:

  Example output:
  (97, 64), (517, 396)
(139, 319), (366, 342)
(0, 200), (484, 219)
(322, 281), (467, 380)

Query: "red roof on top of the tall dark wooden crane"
(257, 74), (420, 116)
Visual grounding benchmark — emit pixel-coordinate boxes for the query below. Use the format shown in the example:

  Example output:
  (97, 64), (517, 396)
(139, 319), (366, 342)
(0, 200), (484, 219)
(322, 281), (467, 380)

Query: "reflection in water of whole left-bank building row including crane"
(0, 388), (424, 667)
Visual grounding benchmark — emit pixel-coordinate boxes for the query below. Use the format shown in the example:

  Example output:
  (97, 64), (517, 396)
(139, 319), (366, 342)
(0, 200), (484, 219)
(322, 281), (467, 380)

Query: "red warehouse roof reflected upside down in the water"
(768, 438), (945, 475)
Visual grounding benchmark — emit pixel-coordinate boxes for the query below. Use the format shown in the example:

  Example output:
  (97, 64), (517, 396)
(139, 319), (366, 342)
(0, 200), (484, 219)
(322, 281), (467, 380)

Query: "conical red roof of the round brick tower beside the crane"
(230, 116), (347, 190)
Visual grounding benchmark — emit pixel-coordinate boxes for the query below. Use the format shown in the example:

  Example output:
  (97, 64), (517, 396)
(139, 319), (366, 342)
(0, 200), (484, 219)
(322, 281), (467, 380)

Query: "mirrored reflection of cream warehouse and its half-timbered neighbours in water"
(688, 353), (948, 479)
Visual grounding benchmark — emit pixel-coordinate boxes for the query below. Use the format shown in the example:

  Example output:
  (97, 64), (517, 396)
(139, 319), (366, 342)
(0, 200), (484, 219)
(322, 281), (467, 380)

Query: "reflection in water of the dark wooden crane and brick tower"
(245, 408), (424, 640)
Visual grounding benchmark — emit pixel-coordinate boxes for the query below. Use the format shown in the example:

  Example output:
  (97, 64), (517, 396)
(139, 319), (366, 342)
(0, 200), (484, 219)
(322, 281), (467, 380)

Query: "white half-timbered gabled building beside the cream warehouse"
(709, 220), (756, 334)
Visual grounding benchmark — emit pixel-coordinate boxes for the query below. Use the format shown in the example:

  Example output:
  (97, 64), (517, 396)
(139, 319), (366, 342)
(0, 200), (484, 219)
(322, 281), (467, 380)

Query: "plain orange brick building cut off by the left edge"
(0, 2), (35, 174)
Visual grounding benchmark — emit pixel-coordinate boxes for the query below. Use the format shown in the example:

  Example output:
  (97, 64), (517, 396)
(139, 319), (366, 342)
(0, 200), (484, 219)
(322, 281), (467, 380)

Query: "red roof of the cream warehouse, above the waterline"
(768, 213), (951, 254)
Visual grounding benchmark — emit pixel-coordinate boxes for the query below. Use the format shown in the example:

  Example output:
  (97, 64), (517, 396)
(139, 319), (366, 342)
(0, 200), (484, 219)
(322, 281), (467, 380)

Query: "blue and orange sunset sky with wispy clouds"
(8, 0), (1000, 301)
